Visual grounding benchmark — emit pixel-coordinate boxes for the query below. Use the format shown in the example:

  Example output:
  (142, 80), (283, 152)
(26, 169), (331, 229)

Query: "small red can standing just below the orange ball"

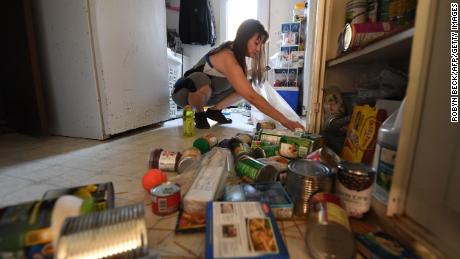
(150, 182), (180, 216)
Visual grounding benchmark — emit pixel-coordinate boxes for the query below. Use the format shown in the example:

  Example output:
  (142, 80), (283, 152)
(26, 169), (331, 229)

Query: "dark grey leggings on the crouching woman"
(172, 72), (235, 107)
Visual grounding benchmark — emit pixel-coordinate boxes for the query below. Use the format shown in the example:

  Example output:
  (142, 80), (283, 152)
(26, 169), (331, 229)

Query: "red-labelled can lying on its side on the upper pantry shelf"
(342, 22), (394, 51)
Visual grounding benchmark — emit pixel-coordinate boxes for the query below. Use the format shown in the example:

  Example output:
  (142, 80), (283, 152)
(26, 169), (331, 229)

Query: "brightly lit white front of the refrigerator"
(89, 0), (169, 135)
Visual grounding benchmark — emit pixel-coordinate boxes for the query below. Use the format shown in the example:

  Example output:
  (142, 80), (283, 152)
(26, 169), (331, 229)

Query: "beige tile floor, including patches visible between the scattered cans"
(0, 113), (314, 258)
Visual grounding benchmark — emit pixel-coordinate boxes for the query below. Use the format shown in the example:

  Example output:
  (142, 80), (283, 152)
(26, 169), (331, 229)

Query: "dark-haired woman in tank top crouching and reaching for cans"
(172, 19), (303, 130)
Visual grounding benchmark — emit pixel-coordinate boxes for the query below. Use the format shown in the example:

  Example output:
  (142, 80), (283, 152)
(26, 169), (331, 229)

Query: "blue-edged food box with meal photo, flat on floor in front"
(205, 202), (289, 258)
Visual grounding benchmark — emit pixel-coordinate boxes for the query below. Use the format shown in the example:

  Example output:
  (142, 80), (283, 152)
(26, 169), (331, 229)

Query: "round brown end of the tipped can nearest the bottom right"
(305, 224), (356, 259)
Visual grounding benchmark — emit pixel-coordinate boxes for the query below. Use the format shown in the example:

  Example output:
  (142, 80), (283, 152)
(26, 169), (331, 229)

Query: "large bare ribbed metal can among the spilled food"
(286, 159), (334, 216)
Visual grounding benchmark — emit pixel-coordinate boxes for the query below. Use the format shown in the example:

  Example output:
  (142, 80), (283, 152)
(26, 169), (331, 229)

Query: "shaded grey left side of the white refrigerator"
(33, 0), (104, 139)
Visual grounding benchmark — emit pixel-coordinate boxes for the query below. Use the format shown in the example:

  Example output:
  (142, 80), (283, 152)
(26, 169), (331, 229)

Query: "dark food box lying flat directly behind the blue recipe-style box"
(224, 182), (293, 219)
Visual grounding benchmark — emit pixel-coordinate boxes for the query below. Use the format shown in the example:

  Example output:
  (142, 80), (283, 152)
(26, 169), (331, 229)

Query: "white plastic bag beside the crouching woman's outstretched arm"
(251, 81), (302, 128)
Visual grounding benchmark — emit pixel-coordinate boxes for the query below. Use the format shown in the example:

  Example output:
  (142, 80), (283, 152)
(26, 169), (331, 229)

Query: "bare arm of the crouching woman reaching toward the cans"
(210, 49), (304, 130)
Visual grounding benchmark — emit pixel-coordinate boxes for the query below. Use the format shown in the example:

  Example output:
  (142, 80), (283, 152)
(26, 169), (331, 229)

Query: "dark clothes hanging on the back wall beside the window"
(179, 0), (216, 46)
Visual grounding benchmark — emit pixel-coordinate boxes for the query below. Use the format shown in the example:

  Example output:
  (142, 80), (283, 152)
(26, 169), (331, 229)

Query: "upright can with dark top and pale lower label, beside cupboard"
(335, 161), (375, 218)
